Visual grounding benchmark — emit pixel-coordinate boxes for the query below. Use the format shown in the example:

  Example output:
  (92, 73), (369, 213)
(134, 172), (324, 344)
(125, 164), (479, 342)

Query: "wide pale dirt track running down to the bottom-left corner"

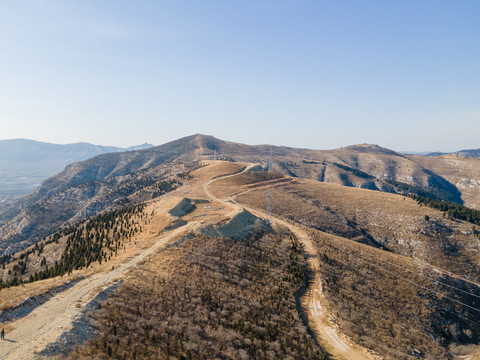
(0, 224), (191, 359)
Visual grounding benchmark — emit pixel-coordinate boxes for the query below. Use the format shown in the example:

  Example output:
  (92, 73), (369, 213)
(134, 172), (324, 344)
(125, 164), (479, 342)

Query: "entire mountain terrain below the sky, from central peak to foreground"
(0, 134), (480, 360)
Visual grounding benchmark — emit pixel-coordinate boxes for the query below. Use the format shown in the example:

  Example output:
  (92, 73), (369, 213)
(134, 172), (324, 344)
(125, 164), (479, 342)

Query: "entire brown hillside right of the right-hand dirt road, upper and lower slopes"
(212, 171), (480, 359)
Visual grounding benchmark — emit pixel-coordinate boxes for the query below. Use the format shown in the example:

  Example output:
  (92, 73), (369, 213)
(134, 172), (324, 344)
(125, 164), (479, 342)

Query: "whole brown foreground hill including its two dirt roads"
(0, 161), (480, 360)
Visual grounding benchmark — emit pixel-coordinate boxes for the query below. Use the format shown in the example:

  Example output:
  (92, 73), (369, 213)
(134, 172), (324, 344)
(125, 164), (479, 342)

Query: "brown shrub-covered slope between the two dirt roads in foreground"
(72, 231), (322, 359)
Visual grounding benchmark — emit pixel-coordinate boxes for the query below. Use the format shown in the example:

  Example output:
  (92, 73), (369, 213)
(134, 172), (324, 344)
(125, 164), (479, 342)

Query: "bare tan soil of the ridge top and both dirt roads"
(0, 161), (476, 360)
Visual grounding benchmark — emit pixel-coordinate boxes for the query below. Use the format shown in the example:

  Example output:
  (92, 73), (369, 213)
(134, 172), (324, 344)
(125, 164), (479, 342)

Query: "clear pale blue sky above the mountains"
(0, 0), (480, 152)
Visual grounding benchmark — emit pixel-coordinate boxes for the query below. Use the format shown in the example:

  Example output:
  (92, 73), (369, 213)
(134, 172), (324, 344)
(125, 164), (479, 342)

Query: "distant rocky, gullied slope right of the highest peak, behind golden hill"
(209, 139), (464, 205)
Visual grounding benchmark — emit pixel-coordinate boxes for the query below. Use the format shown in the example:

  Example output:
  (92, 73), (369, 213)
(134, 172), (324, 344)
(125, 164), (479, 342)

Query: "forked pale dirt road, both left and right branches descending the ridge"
(0, 164), (377, 360)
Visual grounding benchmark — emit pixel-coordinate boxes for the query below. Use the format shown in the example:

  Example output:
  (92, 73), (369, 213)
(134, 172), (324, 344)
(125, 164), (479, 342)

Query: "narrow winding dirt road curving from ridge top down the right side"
(203, 165), (381, 360)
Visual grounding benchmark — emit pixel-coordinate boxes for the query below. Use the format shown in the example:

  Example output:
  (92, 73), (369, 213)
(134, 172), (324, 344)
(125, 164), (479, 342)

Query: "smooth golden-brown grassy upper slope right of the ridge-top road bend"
(225, 179), (480, 281)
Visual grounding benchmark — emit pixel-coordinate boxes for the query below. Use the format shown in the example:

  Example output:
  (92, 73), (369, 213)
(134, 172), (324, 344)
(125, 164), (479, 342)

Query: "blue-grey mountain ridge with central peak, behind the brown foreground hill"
(0, 135), (480, 254)
